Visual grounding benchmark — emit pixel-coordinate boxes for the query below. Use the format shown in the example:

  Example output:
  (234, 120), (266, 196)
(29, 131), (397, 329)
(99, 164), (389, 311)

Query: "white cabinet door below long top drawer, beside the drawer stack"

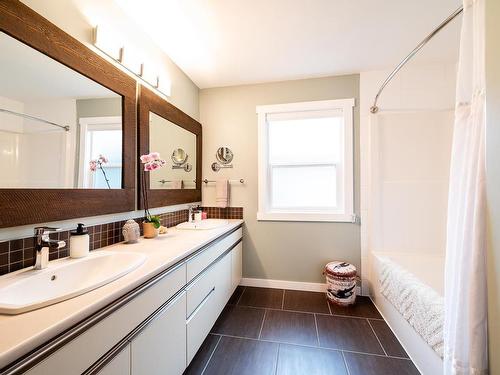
(131, 292), (186, 375)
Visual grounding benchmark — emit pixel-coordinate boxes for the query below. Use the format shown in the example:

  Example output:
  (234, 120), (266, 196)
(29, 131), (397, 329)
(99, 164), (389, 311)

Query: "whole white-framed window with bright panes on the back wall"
(257, 99), (354, 222)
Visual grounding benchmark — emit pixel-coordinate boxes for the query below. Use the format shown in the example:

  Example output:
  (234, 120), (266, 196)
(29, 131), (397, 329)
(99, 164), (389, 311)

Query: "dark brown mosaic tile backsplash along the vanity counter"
(0, 207), (243, 275)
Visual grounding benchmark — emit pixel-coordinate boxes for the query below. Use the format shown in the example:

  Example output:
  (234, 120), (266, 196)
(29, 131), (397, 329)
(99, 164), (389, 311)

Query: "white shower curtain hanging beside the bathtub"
(444, 0), (488, 374)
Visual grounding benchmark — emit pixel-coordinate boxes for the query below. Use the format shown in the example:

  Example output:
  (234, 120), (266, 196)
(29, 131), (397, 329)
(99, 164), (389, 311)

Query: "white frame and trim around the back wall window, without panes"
(257, 98), (356, 223)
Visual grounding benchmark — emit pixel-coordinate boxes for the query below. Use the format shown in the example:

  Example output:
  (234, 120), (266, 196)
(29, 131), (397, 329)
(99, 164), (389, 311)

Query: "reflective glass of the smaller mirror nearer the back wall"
(149, 112), (196, 189)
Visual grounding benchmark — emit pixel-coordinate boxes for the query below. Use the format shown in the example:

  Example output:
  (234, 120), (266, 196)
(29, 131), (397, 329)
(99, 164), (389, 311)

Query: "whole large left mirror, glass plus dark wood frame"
(0, 1), (137, 227)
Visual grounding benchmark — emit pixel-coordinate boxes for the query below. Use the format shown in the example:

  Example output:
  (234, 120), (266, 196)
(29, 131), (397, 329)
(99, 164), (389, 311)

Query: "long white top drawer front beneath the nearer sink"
(26, 264), (186, 375)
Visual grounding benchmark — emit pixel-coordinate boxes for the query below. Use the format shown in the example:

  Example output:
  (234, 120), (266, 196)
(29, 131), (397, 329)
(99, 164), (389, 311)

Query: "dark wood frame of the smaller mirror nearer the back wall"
(137, 85), (202, 209)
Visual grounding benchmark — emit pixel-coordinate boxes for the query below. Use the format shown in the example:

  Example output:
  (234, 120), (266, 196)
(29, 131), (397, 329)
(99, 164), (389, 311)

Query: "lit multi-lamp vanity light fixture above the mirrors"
(94, 25), (171, 96)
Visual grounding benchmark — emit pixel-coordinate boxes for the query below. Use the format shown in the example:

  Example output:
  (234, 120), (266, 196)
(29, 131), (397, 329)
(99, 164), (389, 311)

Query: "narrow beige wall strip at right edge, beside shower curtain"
(486, 0), (500, 375)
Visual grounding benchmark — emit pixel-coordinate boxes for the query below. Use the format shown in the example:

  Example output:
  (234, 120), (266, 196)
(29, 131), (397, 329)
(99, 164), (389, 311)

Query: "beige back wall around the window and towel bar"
(200, 75), (360, 282)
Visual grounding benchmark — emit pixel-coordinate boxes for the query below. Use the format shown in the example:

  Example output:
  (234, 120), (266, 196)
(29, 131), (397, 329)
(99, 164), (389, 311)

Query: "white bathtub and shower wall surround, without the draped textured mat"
(360, 63), (456, 374)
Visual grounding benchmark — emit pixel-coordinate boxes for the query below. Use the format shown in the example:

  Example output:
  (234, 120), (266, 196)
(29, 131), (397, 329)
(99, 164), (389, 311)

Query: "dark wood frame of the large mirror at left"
(0, 0), (137, 228)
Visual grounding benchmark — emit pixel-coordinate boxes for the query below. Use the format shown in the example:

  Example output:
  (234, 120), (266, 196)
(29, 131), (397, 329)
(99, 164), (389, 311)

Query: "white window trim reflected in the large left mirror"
(78, 116), (122, 188)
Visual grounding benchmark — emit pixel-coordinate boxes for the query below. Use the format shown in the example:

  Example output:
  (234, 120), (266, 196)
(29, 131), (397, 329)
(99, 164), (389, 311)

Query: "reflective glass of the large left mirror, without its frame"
(0, 33), (123, 189)
